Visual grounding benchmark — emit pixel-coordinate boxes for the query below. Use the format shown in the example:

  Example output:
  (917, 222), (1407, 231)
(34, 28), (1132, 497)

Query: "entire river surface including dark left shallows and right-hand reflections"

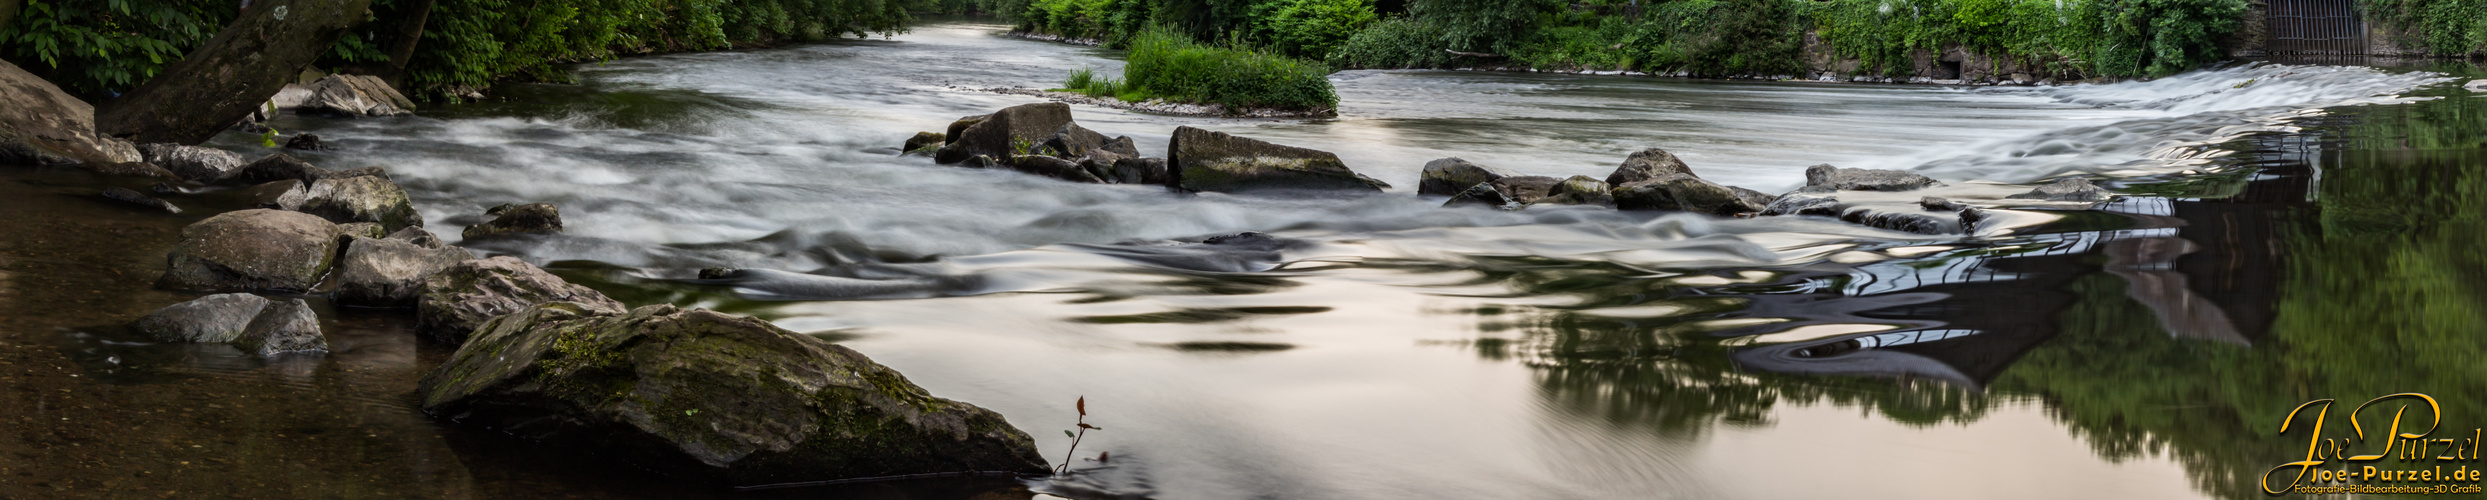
(0, 25), (2487, 498)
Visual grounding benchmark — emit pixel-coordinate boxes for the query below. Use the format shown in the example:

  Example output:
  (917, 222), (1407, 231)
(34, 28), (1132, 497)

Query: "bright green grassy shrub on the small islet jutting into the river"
(1062, 27), (1338, 109)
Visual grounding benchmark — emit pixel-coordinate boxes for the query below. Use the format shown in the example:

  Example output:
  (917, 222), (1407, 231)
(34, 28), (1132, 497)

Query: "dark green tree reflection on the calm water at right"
(1470, 87), (2487, 498)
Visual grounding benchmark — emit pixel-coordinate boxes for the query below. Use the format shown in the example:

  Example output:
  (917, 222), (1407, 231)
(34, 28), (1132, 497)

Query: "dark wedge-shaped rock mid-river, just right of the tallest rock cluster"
(1166, 127), (1390, 192)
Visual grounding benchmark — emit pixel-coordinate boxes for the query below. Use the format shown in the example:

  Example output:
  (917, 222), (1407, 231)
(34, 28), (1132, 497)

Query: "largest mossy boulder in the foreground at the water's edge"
(418, 303), (1047, 485)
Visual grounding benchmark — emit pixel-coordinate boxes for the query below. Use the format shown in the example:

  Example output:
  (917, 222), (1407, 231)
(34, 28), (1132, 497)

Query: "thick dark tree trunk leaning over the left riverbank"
(95, 0), (371, 144)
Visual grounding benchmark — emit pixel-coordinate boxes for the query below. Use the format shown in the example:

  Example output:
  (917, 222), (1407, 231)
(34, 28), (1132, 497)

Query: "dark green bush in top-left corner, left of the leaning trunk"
(0, 0), (236, 100)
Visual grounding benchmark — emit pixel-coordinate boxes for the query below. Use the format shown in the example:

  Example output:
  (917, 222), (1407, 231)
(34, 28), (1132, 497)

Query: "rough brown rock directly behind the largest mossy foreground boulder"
(415, 256), (624, 346)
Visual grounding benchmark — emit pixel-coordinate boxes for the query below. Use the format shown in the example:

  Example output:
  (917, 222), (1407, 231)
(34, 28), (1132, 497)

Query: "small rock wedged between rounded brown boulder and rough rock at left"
(336, 235), (475, 308)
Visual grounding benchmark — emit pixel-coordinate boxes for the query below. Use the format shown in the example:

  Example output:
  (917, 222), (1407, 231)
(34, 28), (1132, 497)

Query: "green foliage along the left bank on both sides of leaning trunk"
(0, 0), (920, 100)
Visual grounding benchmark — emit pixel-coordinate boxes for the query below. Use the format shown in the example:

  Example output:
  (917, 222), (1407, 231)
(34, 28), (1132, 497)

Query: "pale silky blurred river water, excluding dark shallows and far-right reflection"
(155, 25), (2487, 498)
